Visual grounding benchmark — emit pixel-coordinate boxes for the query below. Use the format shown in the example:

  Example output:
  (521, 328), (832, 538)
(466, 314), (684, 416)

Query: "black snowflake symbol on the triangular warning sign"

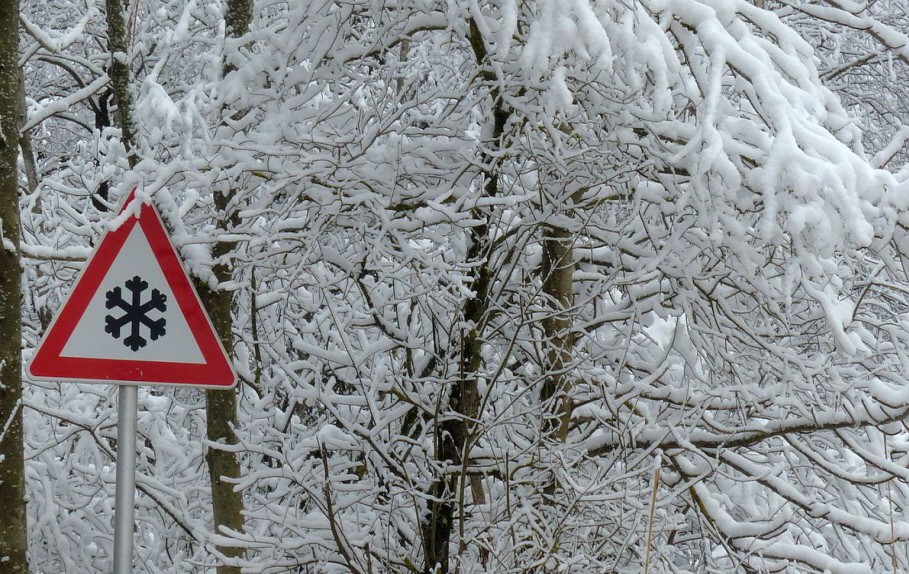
(104, 275), (167, 351)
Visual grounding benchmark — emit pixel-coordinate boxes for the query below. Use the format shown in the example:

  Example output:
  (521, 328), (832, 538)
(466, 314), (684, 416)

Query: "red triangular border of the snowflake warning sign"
(28, 189), (237, 389)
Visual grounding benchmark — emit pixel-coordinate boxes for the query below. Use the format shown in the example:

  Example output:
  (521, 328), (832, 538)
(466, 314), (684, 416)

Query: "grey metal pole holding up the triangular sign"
(114, 385), (139, 574)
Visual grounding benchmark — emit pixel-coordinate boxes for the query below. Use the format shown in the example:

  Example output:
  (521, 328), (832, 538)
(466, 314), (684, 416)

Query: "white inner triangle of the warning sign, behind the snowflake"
(60, 225), (205, 364)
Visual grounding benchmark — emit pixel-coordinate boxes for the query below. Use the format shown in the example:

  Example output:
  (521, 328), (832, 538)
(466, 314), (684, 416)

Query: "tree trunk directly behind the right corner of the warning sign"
(200, 0), (252, 574)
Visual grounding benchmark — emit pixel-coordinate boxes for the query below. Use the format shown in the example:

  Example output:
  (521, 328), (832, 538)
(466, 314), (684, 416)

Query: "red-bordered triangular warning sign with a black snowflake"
(28, 190), (237, 388)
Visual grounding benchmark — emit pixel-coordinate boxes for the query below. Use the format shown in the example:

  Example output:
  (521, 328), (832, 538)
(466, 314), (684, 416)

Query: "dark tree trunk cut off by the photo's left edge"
(0, 0), (28, 574)
